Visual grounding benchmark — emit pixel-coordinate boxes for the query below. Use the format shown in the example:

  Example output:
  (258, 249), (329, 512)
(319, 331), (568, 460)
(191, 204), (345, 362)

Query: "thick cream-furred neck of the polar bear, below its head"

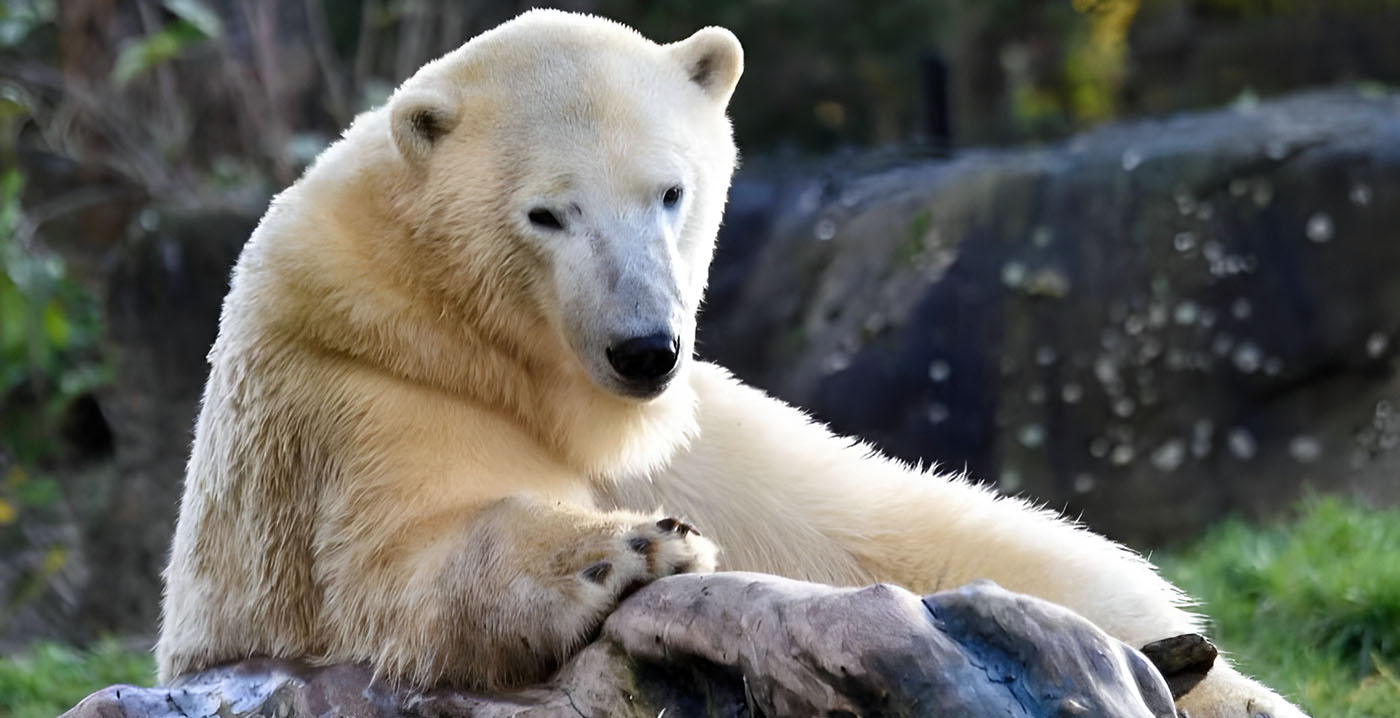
(250, 116), (696, 481)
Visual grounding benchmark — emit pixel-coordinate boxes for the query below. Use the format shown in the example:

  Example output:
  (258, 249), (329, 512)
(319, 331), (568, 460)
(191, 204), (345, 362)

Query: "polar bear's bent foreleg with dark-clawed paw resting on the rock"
(328, 497), (715, 690)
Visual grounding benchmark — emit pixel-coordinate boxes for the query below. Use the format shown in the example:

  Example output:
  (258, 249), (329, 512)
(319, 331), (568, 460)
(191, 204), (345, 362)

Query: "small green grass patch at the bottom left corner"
(0, 641), (155, 718)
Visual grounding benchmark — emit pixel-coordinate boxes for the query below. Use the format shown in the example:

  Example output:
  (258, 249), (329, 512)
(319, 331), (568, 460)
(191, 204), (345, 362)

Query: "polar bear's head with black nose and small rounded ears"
(378, 11), (743, 400)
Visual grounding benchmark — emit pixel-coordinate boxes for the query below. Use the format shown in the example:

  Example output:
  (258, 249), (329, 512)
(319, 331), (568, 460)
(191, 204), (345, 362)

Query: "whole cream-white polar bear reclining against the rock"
(157, 11), (1302, 718)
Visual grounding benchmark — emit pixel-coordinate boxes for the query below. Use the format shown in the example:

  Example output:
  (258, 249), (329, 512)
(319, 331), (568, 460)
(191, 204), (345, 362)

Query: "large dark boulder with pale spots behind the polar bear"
(699, 91), (1400, 544)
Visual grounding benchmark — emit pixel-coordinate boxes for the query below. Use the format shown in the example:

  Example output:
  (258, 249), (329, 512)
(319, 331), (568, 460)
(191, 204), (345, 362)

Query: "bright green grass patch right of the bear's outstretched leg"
(1161, 500), (1400, 718)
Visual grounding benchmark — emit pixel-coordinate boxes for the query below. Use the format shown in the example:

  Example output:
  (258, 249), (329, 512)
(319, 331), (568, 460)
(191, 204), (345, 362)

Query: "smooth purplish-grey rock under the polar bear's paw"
(64, 572), (1176, 718)
